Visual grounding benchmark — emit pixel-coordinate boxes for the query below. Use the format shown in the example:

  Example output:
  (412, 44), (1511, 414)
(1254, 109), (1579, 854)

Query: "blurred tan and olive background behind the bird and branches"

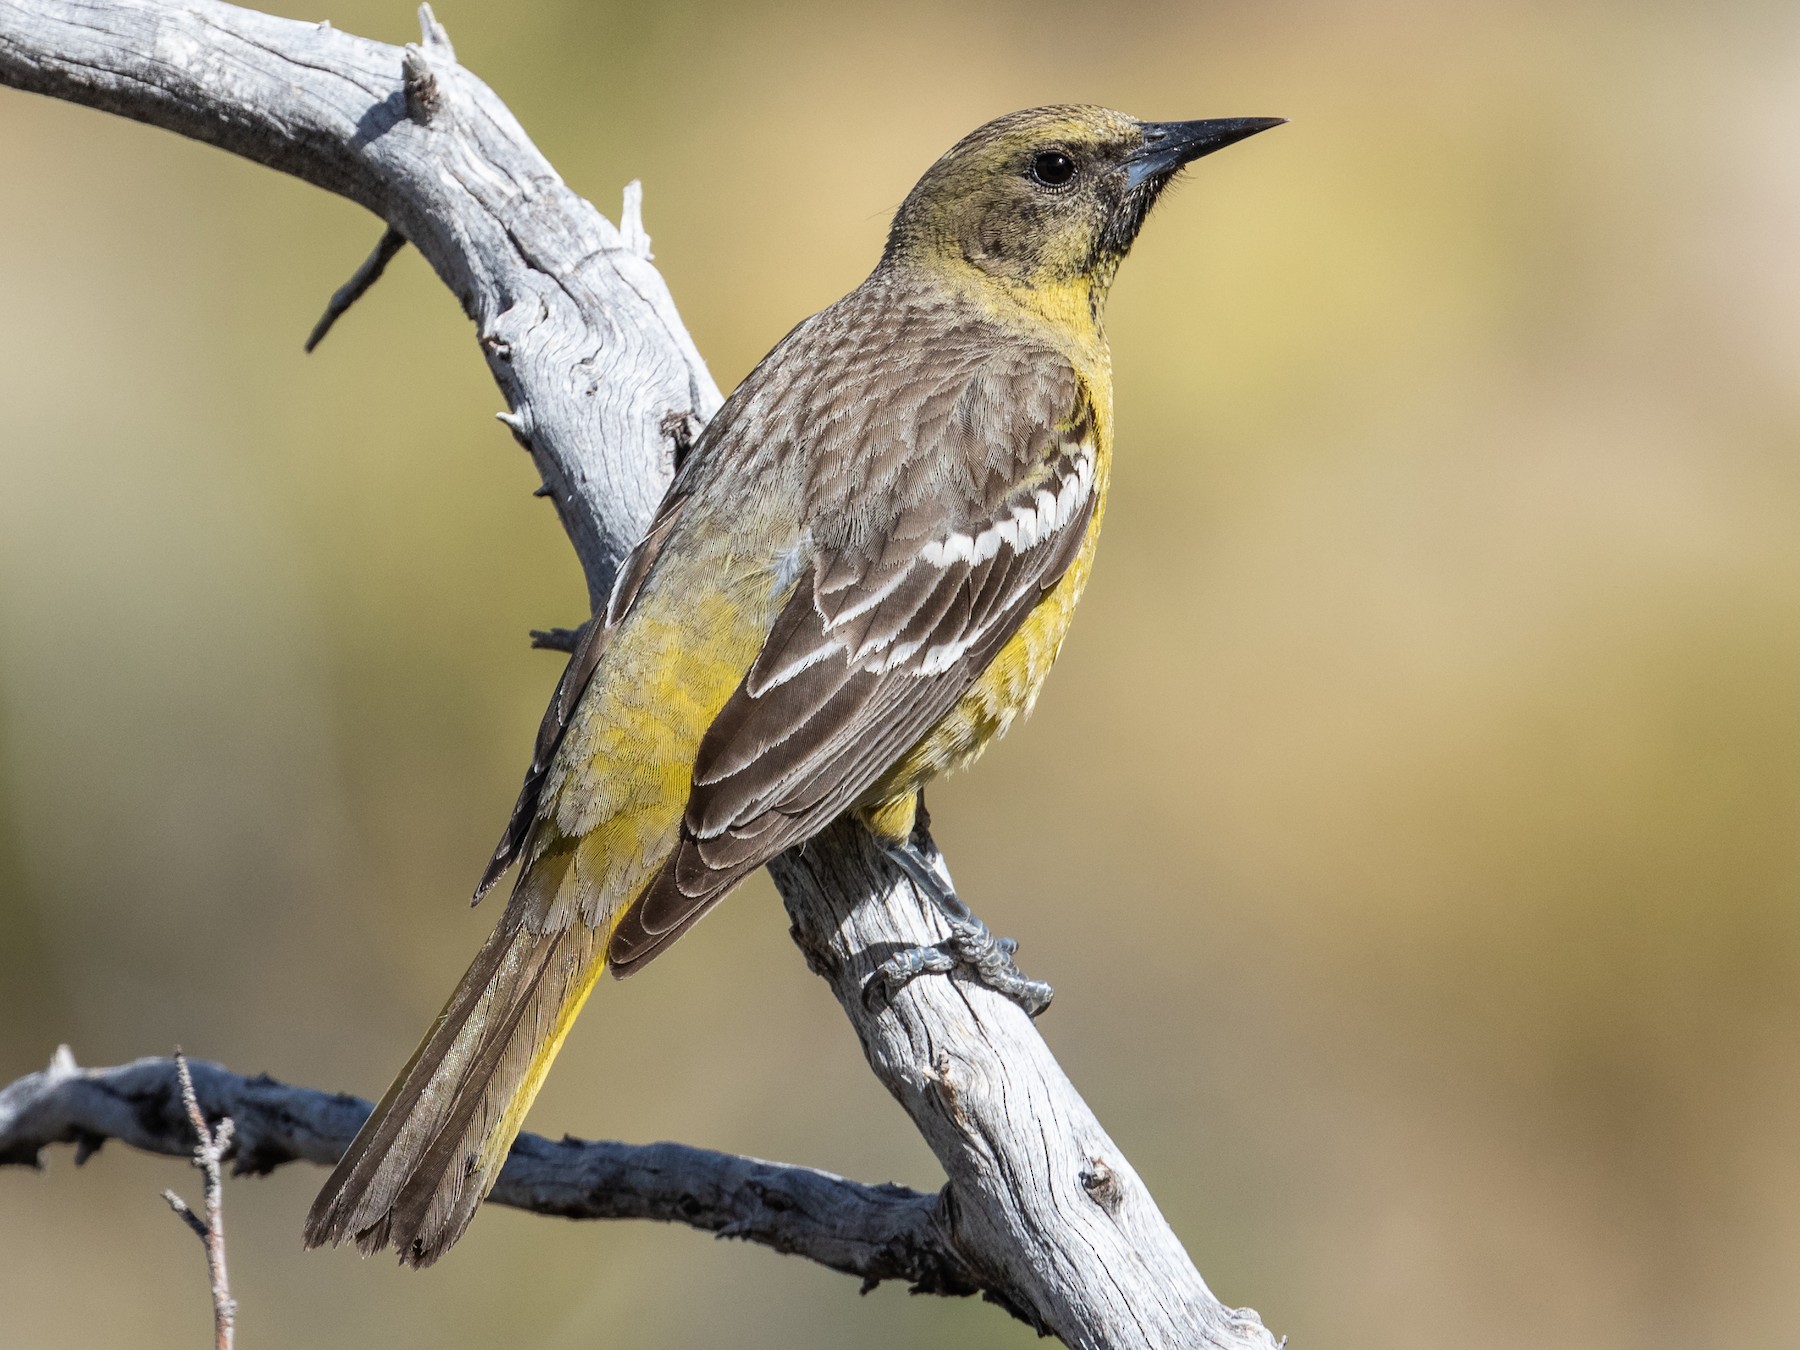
(0, 0), (1800, 1350)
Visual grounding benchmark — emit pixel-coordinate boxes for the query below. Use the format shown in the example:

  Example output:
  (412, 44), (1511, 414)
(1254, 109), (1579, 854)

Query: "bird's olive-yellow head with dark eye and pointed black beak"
(884, 106), (1285, 319)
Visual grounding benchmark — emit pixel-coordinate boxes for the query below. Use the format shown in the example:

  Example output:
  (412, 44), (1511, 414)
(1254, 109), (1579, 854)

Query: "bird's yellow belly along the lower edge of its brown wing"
(864, 448), (1112, 839)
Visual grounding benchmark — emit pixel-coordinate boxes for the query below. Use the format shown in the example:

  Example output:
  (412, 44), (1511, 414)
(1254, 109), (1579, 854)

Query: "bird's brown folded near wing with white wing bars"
(608, 355), (1094, 976)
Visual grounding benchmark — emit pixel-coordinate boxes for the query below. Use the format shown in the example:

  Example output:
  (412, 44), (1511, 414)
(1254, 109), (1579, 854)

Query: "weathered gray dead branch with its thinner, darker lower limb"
(0, 0), (1274, 1350)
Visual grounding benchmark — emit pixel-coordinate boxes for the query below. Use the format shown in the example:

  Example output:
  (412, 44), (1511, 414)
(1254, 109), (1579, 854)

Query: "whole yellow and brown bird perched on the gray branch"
(304, 104), (1285, 1265)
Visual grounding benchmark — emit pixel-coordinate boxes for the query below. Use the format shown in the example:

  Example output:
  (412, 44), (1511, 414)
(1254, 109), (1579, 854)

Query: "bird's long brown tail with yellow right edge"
(306, 878), (608, 1265)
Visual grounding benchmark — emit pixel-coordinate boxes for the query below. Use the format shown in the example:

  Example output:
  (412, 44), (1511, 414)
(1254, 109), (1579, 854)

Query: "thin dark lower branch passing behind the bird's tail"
(0, 1046), (981, 1294)
